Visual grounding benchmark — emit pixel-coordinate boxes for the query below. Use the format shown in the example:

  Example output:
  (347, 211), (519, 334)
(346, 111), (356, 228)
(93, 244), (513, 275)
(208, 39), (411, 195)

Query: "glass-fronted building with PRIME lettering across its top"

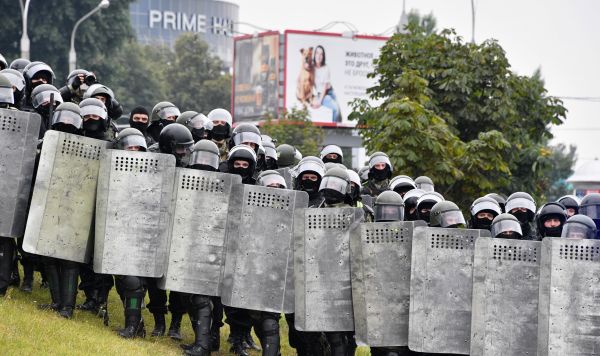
(129, 0), (239, 68)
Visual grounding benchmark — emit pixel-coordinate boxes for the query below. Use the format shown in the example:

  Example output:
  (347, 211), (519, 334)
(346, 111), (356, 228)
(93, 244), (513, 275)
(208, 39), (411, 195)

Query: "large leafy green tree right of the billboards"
(351, 22), (574, 206)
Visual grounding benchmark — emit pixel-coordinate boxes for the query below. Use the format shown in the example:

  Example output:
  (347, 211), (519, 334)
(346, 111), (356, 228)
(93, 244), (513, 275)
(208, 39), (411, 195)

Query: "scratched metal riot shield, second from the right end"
(471, 237), (542, 355)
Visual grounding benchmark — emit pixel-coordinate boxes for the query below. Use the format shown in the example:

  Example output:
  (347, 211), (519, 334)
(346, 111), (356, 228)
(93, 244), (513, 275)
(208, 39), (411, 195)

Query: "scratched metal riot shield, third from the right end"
(408, 227), (490, 354)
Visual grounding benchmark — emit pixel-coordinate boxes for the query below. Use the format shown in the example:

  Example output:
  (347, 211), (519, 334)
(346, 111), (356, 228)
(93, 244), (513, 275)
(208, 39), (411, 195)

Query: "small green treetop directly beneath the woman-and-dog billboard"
(260, 109), (325, 157)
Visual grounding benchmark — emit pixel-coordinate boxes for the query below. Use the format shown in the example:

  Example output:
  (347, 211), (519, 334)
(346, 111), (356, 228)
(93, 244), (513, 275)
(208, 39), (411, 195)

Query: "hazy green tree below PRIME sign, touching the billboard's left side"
(165, 33), (231, 113)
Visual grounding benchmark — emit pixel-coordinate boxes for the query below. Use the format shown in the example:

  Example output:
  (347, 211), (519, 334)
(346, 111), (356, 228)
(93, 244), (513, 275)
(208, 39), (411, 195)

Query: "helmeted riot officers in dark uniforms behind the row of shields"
(0, 58), (600, 356)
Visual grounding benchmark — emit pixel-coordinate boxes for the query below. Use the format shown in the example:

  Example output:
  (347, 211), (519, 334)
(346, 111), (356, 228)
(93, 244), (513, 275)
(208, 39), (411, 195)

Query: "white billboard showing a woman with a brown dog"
(284, 30), (387, 126)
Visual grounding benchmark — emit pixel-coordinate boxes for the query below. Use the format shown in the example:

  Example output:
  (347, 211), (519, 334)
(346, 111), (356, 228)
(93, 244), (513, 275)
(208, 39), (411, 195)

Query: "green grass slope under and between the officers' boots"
(0, 273), (369, 356)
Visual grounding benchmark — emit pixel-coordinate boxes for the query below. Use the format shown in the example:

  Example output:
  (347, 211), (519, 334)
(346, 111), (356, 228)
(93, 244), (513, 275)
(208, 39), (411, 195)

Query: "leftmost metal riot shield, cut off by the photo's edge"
(0, 109), (41, 238)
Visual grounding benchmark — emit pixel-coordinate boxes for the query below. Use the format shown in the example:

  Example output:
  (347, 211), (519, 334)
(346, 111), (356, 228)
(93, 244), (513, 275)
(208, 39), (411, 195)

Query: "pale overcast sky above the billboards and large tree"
(232, 0), (600, 165)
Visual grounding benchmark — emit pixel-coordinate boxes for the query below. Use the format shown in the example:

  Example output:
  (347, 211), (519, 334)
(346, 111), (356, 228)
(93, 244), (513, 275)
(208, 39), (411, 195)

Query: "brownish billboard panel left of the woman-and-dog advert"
(232, 32), (279, 122)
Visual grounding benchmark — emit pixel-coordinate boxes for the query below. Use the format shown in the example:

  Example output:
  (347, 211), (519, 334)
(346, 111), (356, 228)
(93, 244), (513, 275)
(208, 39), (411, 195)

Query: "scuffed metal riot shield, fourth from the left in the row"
(159, 168), (242, 296)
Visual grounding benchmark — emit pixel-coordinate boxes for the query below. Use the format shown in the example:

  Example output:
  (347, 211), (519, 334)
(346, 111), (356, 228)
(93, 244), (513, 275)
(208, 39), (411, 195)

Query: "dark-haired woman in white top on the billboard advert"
(311, 45), (342, 122)
